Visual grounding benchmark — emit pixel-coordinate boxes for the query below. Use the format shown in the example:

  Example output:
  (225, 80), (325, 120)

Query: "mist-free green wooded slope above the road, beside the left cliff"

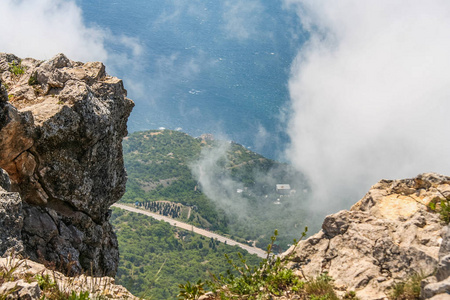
(122, 130), (226, 231)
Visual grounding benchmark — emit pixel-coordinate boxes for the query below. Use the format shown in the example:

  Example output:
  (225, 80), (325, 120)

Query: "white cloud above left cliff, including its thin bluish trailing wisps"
(0, 0), (144, 99)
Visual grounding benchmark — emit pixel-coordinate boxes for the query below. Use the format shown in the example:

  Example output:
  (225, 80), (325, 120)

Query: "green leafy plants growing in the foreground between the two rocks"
(178, 228), (360, 300)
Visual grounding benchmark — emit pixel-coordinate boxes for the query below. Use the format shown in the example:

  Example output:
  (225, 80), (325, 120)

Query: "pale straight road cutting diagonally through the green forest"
(113, 203), (267, 258)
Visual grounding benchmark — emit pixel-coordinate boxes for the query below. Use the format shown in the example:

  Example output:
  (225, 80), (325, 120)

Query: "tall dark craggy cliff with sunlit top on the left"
(0, 53), (134, 276)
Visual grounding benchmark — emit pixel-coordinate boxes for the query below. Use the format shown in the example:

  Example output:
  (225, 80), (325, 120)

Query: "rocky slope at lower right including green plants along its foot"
(198, 173), (450, 300)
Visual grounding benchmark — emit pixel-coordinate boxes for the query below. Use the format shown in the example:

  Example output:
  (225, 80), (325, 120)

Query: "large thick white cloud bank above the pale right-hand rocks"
(285, 0), (450, 213)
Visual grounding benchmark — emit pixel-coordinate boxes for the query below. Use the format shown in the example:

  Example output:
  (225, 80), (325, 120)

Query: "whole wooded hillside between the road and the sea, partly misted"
(122, 130), (311, 251)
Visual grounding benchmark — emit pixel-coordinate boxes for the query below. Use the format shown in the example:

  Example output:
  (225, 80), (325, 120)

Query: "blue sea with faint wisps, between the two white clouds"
(77, 0), (306, 159)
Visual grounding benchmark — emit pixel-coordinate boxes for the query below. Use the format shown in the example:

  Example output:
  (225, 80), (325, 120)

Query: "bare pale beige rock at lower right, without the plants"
(290, 174), (450, 300)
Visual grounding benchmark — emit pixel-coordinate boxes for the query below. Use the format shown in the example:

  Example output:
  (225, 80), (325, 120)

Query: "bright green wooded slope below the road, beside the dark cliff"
(111, 208), (260, 299)
